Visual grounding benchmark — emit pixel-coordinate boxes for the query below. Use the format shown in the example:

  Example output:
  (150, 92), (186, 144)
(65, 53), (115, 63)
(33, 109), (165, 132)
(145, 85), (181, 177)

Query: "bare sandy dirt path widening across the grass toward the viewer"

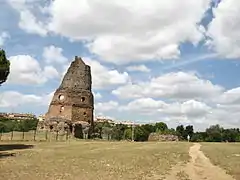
(165, 143), (234, 180)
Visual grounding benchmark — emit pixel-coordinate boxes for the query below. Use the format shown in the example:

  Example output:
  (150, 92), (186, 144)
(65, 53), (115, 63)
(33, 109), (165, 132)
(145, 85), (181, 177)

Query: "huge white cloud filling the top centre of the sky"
(12, 0), (210, 64)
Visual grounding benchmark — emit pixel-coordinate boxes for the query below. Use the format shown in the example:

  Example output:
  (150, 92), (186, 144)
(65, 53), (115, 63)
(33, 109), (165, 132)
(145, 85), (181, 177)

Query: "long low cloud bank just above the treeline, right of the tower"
(119, 98), (240, 130)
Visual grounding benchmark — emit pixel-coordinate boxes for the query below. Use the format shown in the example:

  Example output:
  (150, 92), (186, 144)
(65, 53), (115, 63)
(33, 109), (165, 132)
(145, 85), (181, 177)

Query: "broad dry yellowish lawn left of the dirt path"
(0, 141), (191, 180)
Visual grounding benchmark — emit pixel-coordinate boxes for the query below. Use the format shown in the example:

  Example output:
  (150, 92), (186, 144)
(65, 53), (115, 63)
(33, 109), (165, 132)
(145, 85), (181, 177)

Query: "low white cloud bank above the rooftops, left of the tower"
(0, 91), (53, 108)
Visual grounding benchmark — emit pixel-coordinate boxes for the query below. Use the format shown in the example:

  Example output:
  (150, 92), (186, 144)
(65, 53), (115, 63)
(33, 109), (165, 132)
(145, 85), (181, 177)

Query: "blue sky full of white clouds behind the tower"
(0, 0), (240, 130)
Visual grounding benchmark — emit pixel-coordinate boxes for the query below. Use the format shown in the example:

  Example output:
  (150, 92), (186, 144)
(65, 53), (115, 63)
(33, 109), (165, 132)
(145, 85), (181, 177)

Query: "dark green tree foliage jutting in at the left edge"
(0, 49), (10, 86)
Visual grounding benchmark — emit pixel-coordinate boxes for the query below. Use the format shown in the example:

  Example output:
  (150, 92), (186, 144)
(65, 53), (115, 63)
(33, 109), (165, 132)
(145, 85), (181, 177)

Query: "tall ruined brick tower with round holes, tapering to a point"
(46, 56), (94, 136)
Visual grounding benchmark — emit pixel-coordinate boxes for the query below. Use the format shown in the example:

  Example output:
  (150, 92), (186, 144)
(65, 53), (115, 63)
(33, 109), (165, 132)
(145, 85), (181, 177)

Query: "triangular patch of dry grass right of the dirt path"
(201, 143), (240, 179)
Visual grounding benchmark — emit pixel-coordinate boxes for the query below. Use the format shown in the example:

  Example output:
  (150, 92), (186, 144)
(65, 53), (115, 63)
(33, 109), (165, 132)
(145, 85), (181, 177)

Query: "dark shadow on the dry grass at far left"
(0, 144), (34, 159)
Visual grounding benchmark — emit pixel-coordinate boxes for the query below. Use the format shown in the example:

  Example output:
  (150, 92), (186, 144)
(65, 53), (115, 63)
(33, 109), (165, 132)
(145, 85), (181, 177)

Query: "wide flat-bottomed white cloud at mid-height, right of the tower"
(112, 72), (223, 100)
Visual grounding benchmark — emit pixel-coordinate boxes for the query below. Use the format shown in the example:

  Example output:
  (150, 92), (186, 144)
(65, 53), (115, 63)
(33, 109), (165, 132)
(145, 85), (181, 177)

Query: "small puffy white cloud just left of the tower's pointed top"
(43, 45), (68, 64)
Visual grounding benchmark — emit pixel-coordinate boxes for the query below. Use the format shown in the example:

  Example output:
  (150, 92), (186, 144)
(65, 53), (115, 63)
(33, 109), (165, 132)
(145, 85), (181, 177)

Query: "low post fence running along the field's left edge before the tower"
(0, 130), (72, 141)
